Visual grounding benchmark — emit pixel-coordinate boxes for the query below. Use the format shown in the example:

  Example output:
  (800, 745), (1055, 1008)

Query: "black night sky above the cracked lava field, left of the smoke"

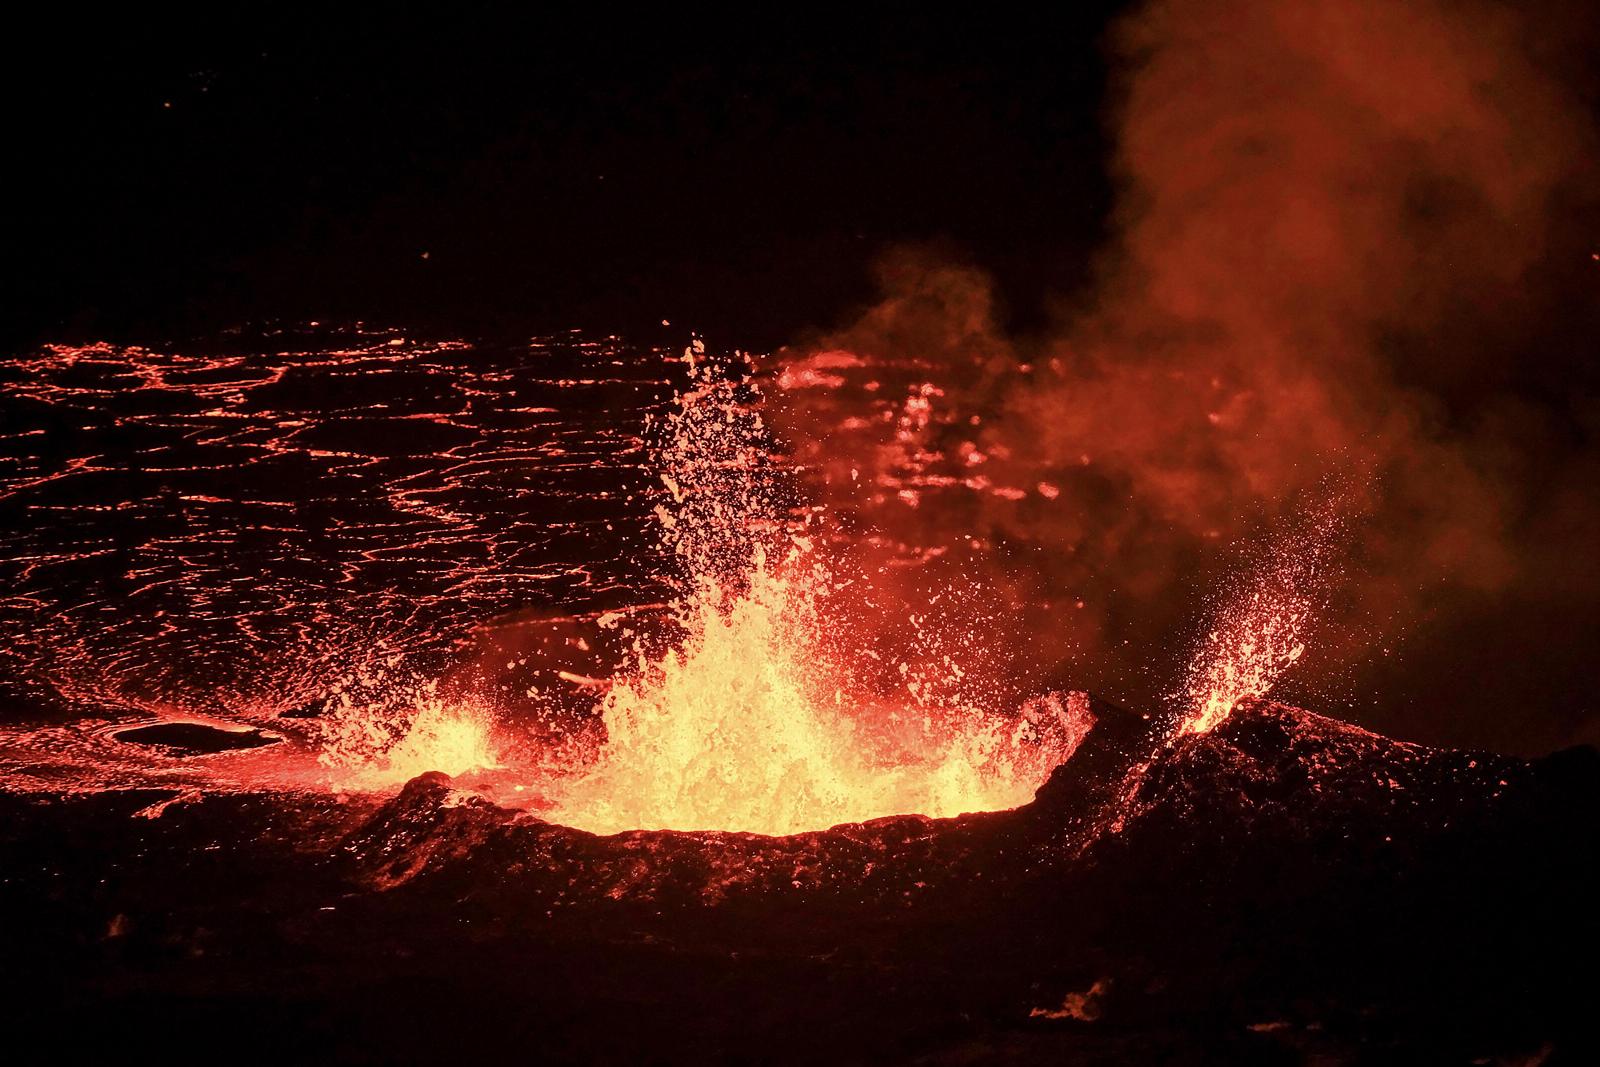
(3, 5), (1110, 347)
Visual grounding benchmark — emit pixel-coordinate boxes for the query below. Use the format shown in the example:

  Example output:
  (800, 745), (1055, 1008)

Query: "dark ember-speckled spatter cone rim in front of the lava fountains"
(331, 701), (1600, 913)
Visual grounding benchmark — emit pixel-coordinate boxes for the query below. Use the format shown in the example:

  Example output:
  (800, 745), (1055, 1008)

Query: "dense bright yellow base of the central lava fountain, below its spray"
(552, 557), (1090, 833)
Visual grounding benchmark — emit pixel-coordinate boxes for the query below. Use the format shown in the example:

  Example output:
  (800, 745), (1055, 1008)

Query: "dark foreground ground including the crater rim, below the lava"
(0, 704), (1600, 1064)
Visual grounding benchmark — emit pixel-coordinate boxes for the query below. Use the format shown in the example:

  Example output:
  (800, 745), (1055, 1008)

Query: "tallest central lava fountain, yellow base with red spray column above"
(547, 344), (1091, 833)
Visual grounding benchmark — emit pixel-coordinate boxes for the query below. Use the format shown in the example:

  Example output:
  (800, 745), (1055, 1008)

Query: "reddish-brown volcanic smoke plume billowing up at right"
(768, 0), (1600, 745)
